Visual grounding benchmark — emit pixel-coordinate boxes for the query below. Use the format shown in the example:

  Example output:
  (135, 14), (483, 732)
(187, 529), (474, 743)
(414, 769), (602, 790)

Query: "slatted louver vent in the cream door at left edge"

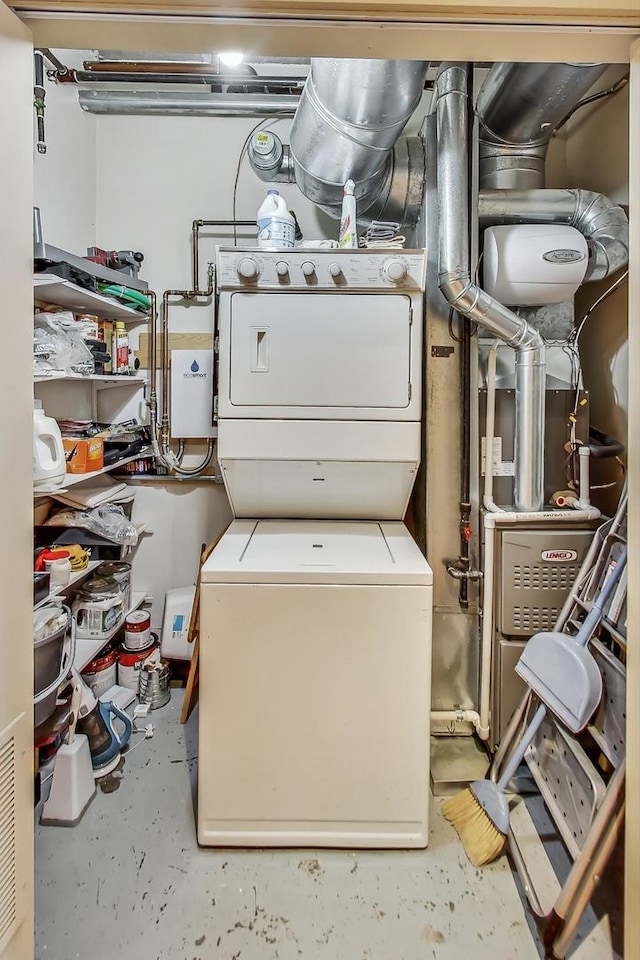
(0, 736), (17, 952)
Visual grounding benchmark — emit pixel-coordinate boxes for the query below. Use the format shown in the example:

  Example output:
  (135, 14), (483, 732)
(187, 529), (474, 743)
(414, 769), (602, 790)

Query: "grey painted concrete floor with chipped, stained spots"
(35, 689), (617, 960)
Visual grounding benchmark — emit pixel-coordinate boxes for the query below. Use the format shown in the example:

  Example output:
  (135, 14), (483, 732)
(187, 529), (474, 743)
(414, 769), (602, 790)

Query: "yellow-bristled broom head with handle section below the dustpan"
(442, 704), (547, 867)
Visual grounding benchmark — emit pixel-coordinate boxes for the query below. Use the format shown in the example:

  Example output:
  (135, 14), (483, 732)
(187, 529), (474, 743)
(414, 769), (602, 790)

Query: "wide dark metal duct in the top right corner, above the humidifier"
(476, 63), (608, 190)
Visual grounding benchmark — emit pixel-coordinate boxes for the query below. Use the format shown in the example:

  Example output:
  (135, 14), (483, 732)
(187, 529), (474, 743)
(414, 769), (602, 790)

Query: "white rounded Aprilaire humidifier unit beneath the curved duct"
(483, 223), (589, 306)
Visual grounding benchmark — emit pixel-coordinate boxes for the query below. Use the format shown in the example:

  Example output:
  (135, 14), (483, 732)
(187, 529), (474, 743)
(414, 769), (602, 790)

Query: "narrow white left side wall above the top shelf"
(34, 69), (96, 256)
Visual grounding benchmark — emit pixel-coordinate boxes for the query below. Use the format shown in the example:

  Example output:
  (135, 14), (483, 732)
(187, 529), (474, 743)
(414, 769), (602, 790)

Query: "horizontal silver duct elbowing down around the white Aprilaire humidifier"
(478, 190), (629, 281)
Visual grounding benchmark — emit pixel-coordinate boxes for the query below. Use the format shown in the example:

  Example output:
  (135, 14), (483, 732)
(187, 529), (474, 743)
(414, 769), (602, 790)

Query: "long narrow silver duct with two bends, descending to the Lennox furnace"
(436, 64), (546, 511)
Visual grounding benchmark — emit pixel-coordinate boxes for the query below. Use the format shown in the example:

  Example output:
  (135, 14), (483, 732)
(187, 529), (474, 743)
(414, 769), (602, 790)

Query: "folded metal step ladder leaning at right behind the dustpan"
(490, 489), (627, 960)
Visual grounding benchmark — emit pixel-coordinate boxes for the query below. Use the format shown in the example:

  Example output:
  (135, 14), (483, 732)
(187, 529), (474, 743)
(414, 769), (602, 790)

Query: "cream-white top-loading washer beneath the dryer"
(198, 520), (432, 848)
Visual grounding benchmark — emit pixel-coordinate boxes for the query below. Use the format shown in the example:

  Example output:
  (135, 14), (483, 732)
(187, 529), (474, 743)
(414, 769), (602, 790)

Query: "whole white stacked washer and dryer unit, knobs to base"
(198, 247), (432, 848)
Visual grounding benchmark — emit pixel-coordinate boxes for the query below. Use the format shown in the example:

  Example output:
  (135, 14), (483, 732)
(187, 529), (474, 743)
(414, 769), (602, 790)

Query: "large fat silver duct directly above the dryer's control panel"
(249, 59), (429, 226)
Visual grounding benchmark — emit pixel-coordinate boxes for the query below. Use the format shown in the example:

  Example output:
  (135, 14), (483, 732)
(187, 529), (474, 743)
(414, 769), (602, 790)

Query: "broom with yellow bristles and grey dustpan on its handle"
(442, 547), (627, 867)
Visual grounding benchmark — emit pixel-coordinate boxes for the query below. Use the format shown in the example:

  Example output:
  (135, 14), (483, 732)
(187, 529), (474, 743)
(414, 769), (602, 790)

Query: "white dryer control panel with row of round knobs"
(216, 247), (425, 292)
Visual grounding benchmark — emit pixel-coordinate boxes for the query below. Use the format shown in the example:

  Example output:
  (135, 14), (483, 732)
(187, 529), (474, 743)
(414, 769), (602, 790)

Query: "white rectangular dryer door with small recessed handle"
(221, 293), (419, 419)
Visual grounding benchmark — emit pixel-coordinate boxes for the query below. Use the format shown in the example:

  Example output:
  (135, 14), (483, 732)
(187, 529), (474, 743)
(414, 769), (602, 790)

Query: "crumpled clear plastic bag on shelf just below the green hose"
(33, 311), (95, 376)
